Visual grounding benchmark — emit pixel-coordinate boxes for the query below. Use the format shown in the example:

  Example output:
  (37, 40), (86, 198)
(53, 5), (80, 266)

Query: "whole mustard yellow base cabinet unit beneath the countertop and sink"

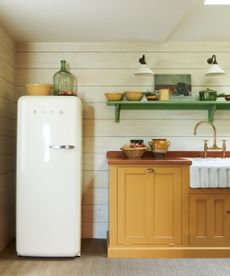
(108, 152), (230, 258)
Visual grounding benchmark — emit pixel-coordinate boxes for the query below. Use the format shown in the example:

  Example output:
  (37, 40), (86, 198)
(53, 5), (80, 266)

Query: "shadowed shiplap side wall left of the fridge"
(0, 27), (17, 251)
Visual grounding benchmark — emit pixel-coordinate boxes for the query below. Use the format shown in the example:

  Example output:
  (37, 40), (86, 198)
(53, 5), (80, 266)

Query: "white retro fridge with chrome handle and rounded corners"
(16, 96), (82, 257)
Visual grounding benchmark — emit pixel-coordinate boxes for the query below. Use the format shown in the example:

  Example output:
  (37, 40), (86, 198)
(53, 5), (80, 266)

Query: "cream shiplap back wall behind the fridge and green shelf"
(16, 42), (230, 238)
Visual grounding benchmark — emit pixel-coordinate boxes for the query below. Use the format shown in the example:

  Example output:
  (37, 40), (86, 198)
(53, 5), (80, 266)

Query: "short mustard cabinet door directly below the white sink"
(190, 194), (230, 246)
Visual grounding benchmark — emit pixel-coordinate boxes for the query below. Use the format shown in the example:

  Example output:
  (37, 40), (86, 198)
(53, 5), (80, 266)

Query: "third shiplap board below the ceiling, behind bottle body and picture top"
(16, 68), (230, 86)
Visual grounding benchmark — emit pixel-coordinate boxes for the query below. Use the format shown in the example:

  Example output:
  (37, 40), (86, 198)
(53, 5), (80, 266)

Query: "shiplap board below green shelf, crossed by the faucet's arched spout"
(84, 118), (230, 137)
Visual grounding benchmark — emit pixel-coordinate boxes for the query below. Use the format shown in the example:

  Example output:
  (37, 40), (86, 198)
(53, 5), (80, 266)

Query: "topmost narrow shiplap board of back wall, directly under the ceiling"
(16, 41), (230, 53)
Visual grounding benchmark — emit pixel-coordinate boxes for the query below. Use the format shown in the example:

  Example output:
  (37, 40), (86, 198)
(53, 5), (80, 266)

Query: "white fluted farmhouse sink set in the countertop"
(187, 158), (230, 188)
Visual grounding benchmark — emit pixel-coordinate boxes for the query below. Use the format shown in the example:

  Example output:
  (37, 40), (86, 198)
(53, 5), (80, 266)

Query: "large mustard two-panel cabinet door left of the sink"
(117, 167), (181, 244)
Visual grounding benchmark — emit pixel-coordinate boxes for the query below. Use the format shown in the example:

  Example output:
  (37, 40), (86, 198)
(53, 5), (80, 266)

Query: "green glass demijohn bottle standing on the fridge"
(53, 60), (74, 95)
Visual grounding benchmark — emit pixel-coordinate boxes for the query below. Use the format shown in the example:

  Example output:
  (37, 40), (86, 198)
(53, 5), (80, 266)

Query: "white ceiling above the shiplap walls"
(0, 0), (230, 42)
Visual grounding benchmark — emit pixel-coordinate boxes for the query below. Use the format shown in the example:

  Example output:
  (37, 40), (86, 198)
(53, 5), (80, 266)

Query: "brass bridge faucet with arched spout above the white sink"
(194, 121), (226, 158)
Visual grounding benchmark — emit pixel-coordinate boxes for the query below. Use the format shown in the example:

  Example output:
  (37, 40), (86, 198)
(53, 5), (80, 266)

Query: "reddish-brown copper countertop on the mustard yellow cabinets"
(107, 151), (230, 166)
